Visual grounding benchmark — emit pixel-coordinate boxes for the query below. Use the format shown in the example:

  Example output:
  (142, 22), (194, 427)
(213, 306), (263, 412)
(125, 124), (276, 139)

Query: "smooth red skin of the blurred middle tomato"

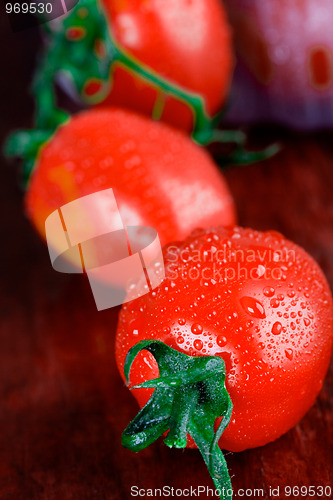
(25, 109), (235, 244)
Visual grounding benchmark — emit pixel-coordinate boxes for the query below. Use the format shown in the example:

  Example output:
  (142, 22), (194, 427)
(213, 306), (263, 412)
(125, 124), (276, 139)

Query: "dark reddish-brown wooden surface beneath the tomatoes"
(0, 9), (333, 500)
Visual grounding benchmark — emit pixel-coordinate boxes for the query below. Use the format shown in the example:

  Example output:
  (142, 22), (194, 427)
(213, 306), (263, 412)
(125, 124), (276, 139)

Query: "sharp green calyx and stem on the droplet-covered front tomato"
(122, 340), (232, 500)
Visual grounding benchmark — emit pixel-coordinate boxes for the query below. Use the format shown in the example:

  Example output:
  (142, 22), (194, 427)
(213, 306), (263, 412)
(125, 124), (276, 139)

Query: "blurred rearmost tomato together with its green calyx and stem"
(39, 0), (234, 133)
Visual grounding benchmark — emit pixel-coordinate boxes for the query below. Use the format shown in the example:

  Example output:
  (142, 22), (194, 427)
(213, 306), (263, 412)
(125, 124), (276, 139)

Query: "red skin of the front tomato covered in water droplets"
(116, 228), (333, 451)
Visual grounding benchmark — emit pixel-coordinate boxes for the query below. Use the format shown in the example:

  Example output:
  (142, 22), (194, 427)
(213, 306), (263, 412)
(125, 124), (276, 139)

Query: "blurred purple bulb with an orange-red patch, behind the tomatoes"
(226, 0), (333, 129)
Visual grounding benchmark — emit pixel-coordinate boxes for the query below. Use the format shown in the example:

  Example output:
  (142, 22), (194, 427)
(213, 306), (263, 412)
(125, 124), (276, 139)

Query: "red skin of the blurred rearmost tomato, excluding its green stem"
(102, 0), (234, 131)
